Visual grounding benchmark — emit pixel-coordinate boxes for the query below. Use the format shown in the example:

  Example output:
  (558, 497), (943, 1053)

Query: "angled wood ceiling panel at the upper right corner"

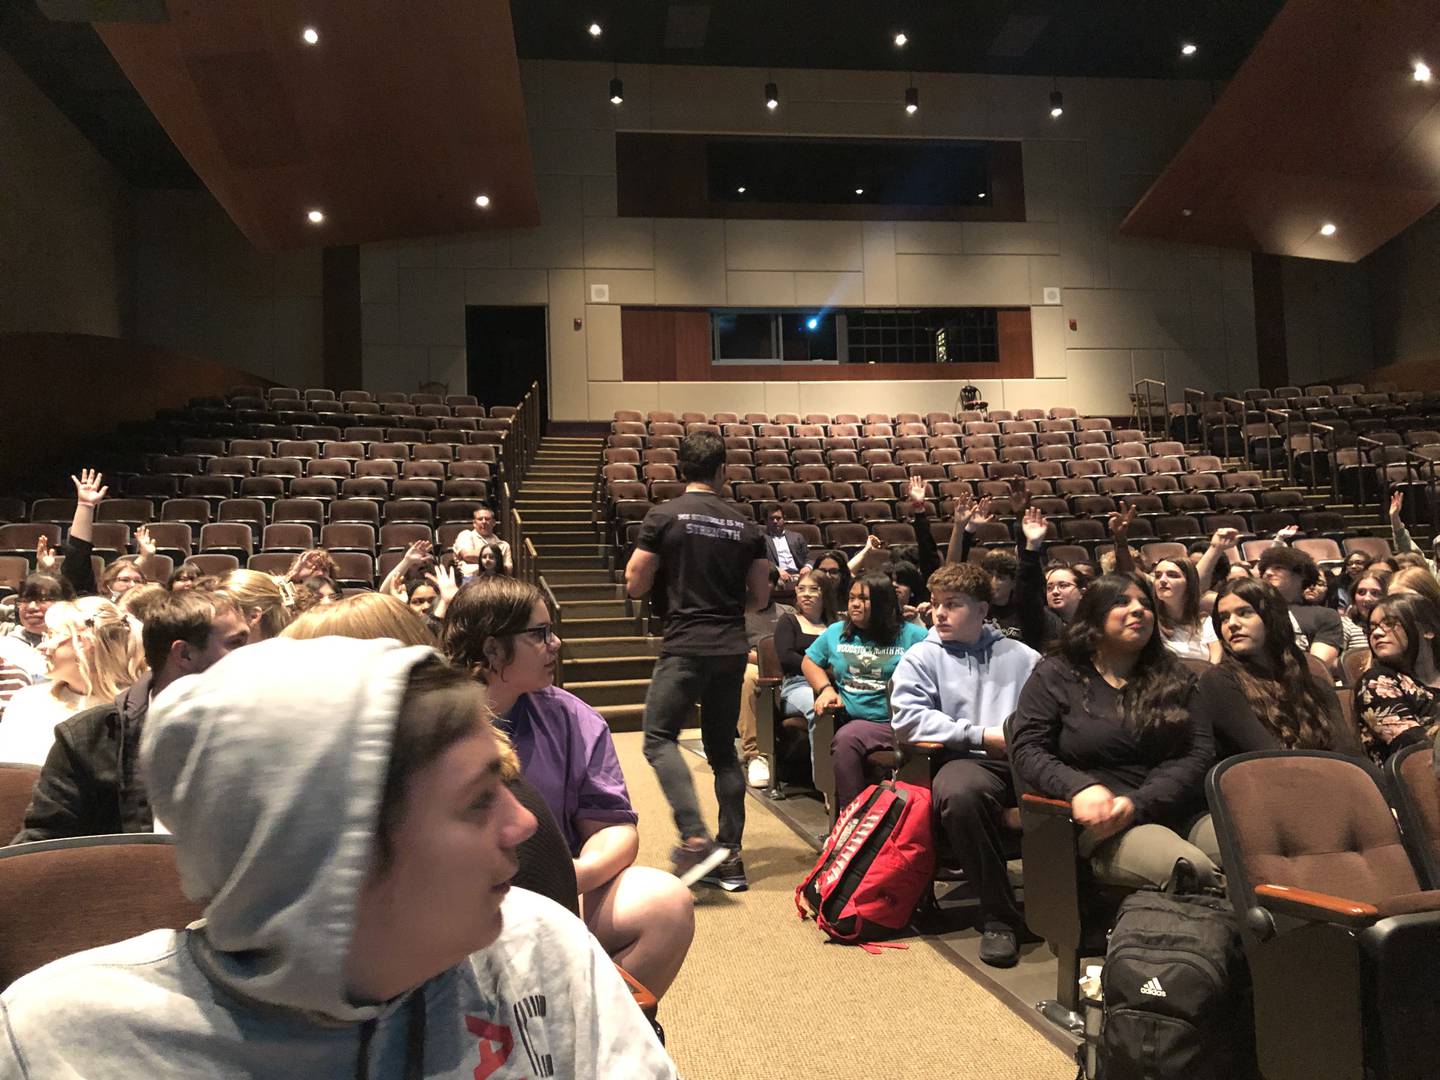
(1120, 0), (1440, 262)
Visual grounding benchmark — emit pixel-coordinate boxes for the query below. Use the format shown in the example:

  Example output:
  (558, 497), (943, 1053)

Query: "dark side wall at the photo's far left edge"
(0, 52), (130, 337)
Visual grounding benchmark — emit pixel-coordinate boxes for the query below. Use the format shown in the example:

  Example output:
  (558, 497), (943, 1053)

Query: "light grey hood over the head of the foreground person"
(141, 638), (436, 1021)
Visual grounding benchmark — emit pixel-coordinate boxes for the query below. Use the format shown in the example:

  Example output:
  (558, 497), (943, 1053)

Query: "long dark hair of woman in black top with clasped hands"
(1056, 573), (1195, 749)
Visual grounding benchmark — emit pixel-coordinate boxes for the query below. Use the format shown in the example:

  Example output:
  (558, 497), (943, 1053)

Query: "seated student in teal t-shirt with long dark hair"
(801, 572), (926, 806)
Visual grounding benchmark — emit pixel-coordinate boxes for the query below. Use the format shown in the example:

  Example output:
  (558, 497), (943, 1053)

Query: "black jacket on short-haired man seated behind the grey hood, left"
(10, 675), (154, 844)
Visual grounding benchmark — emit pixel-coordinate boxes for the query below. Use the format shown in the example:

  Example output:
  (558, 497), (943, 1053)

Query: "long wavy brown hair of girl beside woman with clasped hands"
(1210, 577), (1333, 750)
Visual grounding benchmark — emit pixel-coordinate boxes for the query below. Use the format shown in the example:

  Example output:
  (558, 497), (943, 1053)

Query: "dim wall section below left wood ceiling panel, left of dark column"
(131, 190), (324, 386)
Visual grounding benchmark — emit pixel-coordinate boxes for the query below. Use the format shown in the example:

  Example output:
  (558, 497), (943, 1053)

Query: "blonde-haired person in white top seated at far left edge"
(0, 596), (145, 766)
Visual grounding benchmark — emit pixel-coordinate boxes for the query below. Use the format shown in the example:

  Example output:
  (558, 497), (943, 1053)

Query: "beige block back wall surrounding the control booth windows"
(361, 60), (1256, 419)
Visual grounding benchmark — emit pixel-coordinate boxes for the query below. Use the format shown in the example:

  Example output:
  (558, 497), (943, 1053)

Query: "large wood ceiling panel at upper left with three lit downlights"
(95, 0), (540, 248)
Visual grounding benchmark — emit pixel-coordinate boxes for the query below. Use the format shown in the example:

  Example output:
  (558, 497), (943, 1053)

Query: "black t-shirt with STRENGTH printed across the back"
(635, 491), (765, 657)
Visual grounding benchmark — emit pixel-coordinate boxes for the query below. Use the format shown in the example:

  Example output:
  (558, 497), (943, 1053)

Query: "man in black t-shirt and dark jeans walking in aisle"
(625, 432), (770, 891)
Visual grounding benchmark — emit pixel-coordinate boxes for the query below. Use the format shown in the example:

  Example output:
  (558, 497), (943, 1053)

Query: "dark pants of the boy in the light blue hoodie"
(930, 757), (1025, 929)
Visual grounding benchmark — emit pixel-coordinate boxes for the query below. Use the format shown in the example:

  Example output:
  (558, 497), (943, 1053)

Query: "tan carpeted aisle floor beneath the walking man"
(615, 733), (1074, 1080)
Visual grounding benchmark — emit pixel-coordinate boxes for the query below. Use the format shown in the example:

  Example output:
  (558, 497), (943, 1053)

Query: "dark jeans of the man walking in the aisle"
(645, 652), (744, 851)
